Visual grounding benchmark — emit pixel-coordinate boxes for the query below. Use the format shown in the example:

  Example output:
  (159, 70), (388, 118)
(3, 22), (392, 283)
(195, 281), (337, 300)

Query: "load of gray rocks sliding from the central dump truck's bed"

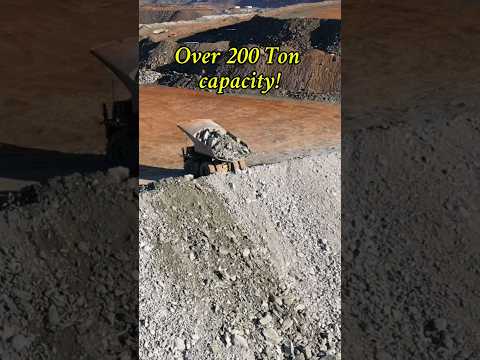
(196, 129), (250, 161)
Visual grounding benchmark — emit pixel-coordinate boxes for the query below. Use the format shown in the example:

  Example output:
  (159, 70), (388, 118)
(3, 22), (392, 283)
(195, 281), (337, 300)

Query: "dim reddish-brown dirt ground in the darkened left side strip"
(0, 0), (138, 193)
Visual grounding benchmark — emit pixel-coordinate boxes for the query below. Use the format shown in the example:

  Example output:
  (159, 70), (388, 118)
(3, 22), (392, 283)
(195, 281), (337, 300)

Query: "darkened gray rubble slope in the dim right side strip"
(342, 97), (480, 360)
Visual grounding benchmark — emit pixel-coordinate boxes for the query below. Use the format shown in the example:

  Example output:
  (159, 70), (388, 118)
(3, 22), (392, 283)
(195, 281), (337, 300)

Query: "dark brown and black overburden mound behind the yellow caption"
(140, 16), (341, 101)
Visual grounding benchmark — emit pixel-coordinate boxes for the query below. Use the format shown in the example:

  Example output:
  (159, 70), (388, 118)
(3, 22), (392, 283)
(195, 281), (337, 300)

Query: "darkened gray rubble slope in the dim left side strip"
(0, 168), (138, 360)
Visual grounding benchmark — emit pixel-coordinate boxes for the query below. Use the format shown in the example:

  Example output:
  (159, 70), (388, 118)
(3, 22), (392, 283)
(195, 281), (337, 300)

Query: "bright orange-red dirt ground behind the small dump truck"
(140, 87), (340, 169)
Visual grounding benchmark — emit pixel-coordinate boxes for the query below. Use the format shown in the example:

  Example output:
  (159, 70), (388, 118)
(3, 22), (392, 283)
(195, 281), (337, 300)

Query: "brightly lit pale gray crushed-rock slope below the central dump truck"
(139, 150), (341, 360)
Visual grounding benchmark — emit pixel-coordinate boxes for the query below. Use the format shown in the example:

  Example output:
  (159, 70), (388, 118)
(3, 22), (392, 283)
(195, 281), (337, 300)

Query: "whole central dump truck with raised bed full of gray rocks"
(178, 119), (250, 177)
